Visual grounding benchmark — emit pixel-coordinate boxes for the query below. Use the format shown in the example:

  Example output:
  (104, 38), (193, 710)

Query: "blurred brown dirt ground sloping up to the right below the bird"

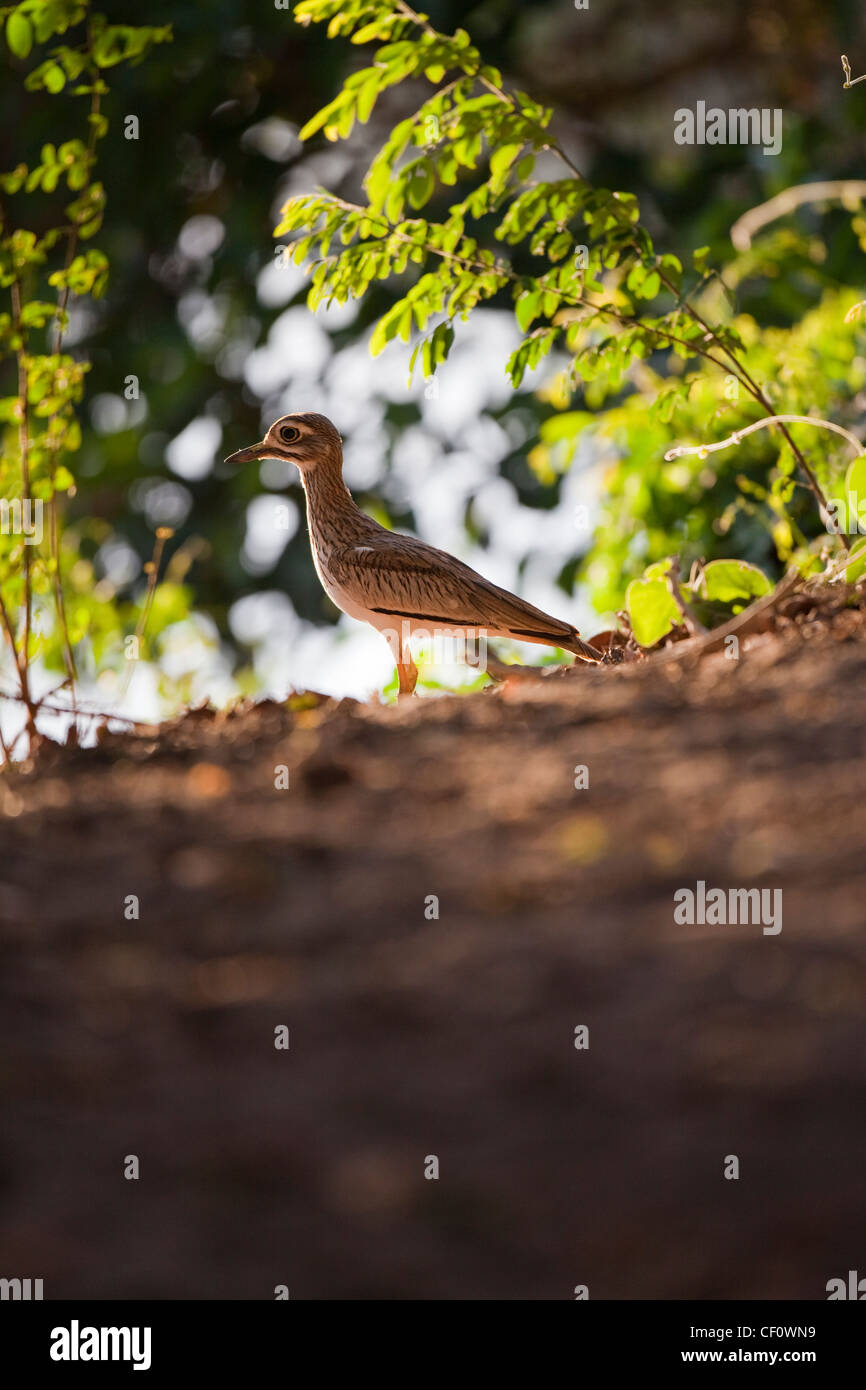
(0, 589), (866, 1300)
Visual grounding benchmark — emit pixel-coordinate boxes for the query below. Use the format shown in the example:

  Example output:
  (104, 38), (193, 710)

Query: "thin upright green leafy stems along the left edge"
(0, 0), (177, 750)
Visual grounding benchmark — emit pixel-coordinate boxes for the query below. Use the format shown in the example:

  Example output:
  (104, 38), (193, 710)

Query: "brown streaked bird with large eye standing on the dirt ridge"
(225, 411), (603, 696)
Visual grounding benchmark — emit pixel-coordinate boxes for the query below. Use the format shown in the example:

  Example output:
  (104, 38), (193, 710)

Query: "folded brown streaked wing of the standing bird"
(329, 531), (586, 645)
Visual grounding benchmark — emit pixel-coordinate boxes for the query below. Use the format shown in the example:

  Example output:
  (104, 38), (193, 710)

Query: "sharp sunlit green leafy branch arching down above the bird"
(287, 0), (848, 556)
